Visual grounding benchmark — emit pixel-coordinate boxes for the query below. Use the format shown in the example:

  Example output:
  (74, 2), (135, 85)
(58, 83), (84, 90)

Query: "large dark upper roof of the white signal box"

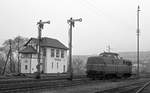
(25, 37), (68, 50)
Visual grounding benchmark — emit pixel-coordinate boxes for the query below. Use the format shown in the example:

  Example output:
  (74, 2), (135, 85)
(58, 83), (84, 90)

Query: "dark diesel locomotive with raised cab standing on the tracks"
(86, 52), (132, 79)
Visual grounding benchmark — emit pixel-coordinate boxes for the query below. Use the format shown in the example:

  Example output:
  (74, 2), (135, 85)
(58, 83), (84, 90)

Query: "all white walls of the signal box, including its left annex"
(21, 47), (67, 73)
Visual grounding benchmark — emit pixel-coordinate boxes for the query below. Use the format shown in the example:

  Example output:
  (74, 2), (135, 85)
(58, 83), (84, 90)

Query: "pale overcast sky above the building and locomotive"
(0, 0), (150, 55)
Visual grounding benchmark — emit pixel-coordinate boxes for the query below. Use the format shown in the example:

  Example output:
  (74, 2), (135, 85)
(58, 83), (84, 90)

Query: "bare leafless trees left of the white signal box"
(0, 36), (28, 73)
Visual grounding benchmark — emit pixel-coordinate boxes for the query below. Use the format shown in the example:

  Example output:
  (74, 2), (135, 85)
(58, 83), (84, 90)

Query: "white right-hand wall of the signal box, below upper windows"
(45, 48), (67, 73)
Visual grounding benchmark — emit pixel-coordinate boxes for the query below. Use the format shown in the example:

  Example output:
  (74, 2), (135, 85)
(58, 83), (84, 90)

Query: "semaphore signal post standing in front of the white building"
(36, 20), (50, 79)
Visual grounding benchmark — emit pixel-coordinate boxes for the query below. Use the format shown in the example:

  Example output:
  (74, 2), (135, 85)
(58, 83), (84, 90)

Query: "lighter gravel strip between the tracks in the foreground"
(19, 79), (149, 93)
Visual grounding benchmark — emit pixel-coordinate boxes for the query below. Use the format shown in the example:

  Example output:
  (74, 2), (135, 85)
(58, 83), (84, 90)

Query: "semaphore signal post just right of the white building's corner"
(67, 18), (82, 80)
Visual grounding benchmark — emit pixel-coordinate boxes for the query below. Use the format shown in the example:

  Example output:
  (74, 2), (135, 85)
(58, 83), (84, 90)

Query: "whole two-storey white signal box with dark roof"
(20, 37), (68, 73)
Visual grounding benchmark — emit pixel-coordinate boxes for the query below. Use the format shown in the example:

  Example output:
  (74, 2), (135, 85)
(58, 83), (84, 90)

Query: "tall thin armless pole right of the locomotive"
(137, 5), (140, 77)
